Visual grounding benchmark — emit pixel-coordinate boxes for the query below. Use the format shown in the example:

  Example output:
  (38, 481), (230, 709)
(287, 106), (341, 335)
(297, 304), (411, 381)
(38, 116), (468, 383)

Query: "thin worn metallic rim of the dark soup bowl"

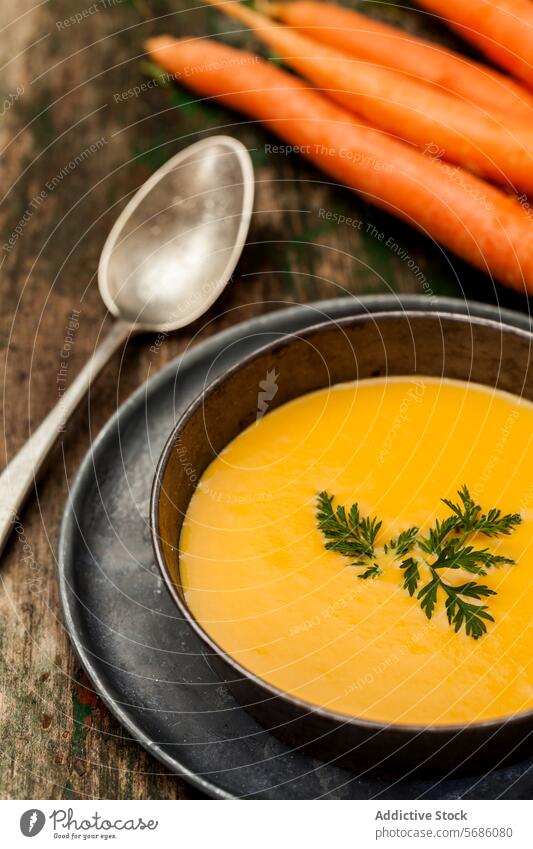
(150, 309), (533, 736)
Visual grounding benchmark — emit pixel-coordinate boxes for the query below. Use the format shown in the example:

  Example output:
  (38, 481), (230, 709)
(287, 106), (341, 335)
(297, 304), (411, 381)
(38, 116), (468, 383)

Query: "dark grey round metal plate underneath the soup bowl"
(59, 296), (533, 799)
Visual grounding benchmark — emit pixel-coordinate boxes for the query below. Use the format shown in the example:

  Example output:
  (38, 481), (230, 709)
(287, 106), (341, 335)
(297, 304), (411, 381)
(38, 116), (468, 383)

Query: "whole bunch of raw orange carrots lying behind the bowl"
(147, 0), (533, 294)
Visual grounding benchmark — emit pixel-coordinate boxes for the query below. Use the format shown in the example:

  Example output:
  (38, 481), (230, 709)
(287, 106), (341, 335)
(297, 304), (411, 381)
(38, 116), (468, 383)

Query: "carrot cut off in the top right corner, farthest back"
(417, 0), (533, 87)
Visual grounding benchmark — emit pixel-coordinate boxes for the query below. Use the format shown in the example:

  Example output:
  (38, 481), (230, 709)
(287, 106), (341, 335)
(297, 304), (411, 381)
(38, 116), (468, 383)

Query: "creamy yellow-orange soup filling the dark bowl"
(181, 376), (533, 724)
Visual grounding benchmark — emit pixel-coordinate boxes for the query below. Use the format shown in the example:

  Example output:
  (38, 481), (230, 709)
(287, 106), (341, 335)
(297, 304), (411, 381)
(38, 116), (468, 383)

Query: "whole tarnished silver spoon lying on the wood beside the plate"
(0, 136), (254, 554)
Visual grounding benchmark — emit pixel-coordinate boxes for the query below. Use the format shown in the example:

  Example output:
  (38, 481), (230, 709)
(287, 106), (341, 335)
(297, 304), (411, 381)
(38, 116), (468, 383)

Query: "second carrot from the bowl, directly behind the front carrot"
(202, 0), (533, 193)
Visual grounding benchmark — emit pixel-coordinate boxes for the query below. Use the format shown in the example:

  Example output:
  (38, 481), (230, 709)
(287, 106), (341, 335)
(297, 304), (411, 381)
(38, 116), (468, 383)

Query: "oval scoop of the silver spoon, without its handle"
(98, 136), (253, 332)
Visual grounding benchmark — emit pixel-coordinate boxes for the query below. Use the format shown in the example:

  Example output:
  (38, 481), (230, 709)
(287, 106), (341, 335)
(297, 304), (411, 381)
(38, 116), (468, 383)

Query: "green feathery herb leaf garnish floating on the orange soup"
(317, 486), (522, 640)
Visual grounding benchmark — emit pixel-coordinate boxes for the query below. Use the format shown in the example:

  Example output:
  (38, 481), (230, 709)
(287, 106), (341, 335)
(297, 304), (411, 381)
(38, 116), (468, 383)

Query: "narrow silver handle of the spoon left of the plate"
(0, 321), (131, 555)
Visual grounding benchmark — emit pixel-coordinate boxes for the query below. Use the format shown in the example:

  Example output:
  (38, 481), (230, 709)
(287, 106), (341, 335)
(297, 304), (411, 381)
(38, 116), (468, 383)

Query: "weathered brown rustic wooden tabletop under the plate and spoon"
(0, 0), (527, 799)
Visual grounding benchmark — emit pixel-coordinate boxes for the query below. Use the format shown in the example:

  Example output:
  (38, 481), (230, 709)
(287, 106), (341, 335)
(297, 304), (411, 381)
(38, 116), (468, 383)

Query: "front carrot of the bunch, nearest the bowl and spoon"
(146, 36), (533, 294)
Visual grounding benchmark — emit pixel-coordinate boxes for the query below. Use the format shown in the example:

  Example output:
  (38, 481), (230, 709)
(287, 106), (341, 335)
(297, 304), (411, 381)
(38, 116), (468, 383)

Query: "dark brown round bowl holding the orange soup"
(151, 312), (533, 774)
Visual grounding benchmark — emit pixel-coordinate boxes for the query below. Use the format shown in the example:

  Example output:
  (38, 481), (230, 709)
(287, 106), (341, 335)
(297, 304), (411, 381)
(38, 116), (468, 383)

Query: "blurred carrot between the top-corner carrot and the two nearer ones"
(257, 0), (533, 121)
